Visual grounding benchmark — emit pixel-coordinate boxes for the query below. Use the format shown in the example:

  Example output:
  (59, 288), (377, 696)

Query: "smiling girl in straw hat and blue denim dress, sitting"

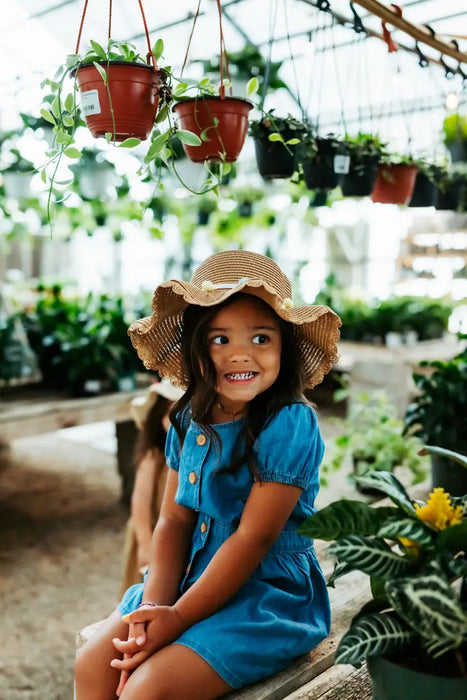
(76, 250), (340, 700)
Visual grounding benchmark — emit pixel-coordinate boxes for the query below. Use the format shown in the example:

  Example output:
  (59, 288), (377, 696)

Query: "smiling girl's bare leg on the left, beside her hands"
(75, 610), (128, 700)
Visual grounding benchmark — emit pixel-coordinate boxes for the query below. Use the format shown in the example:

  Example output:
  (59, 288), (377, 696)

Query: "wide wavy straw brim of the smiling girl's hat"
(128, 277), (341, 389)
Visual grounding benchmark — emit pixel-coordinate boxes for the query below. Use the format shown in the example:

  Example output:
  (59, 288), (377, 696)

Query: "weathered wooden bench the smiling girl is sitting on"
(76, 542), (371, 700)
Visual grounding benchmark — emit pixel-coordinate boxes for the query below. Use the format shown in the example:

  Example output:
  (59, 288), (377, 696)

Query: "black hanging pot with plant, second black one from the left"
(300, 129), (341, 190)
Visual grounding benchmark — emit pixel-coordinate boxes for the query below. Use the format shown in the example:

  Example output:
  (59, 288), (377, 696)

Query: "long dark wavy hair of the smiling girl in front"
(169, 293), (308, 478)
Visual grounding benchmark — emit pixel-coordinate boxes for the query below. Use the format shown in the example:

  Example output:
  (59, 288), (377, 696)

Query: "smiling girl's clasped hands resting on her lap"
(110, 605), (188, 671)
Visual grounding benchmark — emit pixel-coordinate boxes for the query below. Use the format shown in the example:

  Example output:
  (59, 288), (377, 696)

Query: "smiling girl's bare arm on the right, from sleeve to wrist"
(174, 482), (302, 627)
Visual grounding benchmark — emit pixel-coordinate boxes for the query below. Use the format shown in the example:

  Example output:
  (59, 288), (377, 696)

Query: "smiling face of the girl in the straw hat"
(208, 297), (282, 413)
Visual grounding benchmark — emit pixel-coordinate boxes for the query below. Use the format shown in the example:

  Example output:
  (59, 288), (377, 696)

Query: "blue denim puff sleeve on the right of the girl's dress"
(254, 403), (324, 490)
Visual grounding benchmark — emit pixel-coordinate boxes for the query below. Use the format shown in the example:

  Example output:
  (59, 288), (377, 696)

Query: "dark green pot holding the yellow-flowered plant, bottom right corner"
(367, 656), (467, 700)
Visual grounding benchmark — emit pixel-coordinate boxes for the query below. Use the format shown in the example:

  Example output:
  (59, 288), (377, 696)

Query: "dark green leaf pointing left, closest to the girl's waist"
(298, 499), (396, 540)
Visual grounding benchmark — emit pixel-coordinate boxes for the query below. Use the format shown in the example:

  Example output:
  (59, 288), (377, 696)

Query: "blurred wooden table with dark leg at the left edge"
(0, 389), (146, 503)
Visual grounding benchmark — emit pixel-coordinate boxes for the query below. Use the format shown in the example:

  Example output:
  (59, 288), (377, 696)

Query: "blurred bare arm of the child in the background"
(131, 450), (159, 566)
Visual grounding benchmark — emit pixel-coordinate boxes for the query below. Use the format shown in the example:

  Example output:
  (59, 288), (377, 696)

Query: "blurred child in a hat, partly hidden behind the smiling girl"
(122, 379), (183, 595)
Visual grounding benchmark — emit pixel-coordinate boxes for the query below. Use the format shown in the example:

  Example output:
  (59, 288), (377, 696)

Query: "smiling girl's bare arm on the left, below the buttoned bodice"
(143, 469), (196, 605)
